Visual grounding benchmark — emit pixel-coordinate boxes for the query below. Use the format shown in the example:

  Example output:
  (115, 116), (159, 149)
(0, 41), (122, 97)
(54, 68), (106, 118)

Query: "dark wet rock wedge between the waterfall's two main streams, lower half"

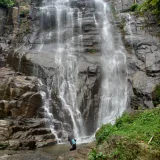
(78, 56), (101, 133)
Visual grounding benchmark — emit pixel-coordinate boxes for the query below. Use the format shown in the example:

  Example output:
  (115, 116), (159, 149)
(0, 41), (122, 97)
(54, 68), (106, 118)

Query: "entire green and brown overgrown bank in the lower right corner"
(88, 107), (160, 160)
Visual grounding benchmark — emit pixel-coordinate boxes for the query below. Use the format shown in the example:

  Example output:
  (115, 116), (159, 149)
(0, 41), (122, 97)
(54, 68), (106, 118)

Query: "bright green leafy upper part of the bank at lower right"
(96, 107), (160, 148)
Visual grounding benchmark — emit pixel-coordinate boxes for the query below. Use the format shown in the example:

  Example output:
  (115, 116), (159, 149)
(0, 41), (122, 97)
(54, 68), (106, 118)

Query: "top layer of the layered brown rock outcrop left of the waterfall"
(0, 68), (41, 99)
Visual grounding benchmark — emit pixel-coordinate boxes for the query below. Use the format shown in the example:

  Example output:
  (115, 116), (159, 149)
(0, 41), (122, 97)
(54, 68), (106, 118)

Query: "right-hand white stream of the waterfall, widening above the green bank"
(95, 0), (127, 127)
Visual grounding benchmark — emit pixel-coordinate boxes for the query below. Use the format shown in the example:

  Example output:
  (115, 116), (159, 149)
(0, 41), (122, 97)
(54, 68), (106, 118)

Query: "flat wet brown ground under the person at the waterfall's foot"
(0, 142), (95, 160)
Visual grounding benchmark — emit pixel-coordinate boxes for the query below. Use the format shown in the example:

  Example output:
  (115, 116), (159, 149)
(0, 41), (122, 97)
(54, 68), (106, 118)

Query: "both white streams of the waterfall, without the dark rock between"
(35, 0), (127, 143)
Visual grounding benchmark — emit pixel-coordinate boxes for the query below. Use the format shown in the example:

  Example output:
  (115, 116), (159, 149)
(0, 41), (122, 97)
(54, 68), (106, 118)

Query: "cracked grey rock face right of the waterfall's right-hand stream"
(117, 2), (160, 109)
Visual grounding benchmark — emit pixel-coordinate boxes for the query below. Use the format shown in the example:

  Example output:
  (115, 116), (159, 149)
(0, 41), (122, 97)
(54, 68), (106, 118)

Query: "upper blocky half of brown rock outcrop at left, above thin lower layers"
(0, 68), (43, 118)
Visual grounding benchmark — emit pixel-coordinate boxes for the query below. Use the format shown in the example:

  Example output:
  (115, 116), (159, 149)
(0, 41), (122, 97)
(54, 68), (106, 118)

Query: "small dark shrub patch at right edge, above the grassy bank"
(152, 84), (160, 106)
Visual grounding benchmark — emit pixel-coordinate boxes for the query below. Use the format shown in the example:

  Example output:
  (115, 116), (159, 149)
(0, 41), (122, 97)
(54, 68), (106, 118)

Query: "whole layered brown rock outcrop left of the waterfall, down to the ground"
(0, 68), (58, 150)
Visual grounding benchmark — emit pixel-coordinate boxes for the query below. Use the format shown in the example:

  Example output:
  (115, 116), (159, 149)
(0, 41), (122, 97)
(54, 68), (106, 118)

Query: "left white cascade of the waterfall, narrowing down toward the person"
(38, 0), (85, 141)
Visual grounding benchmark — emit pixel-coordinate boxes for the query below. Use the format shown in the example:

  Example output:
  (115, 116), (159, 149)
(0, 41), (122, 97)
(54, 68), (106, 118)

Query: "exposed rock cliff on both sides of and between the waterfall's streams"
(0, 0), (160, 150)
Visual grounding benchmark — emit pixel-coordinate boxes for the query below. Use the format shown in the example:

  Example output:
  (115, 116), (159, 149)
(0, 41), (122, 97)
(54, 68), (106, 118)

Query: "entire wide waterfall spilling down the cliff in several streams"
(35, 0), (127, 142)
